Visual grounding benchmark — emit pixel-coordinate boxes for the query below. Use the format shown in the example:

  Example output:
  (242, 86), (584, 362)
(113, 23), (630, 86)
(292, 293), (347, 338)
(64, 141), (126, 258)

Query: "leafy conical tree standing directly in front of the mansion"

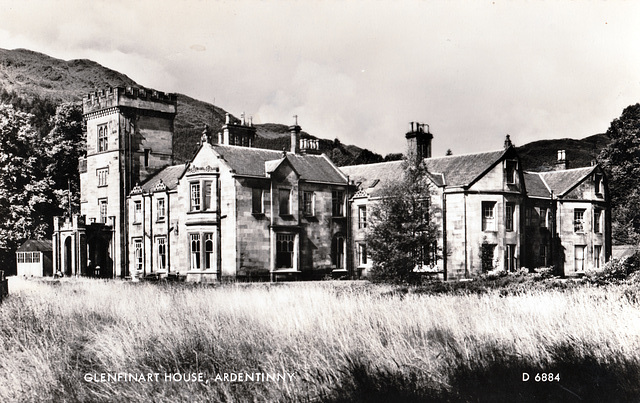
(366, 156), (438, 282)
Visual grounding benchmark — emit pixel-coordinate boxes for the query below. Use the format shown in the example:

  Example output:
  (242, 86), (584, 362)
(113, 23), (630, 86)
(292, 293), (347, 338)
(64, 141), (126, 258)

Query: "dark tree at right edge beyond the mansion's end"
(598, 104), (640, 243)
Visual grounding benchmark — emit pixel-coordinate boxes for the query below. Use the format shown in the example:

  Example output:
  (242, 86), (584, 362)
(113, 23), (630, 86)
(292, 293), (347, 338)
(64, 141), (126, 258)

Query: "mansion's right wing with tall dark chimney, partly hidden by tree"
(341, 128), (611, 280)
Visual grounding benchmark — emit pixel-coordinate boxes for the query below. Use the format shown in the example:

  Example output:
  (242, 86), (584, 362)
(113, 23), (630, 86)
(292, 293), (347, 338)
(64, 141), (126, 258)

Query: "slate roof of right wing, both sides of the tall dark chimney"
(340, 150), (506, 196)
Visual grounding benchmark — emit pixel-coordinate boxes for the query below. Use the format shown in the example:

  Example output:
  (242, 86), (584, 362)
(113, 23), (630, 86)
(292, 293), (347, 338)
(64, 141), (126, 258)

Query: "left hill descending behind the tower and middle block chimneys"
(0, 49), (382, 164)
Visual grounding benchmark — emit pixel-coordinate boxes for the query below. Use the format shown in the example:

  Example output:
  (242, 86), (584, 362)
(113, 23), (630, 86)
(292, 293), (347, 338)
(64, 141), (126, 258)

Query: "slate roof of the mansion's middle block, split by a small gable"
(213, 144), (346, 184)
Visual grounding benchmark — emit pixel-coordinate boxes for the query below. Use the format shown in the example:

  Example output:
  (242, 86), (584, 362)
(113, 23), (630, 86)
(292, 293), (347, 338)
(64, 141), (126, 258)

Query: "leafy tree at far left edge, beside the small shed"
(0, 105), (53, 267)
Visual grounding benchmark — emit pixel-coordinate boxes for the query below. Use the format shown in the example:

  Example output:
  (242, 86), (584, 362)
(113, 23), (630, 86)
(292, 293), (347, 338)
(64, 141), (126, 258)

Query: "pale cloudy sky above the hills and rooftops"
(0, 0), (640, 156)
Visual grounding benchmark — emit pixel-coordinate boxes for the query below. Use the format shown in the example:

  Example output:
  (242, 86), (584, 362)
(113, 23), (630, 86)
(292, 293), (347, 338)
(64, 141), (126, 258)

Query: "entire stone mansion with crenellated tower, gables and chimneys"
(53, 88), (611, 282)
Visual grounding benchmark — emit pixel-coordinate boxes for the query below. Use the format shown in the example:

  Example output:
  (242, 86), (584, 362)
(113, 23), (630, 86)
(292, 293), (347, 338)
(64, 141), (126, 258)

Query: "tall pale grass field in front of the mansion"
(0, 278), (640, 402)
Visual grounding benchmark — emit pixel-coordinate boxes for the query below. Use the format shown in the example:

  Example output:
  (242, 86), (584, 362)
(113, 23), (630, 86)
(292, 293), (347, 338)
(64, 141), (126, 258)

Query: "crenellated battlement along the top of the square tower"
(82, 87), (178, 115)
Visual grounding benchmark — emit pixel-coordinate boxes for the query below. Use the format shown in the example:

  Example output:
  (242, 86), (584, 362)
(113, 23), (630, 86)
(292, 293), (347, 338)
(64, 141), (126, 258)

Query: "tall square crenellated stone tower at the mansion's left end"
(66, 87), (177, 277)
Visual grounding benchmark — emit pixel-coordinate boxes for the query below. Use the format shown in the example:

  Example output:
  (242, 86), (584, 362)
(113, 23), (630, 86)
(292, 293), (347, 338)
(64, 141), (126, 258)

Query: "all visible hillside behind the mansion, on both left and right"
(0, 49), (609, 171)
